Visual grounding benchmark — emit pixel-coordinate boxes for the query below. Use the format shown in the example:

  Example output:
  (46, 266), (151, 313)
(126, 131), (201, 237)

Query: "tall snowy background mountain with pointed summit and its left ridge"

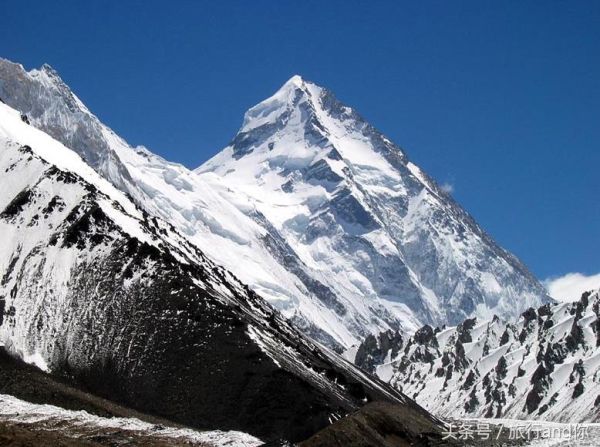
(0, 60), (549, 351)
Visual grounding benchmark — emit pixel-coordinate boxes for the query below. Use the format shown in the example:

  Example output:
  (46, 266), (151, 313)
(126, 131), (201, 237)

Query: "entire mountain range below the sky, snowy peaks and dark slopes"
(0, 59), (584, 446)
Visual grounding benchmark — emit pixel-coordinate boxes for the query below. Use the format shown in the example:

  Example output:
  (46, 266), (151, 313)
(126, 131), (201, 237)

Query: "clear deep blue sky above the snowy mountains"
(0, 0), (600, 278)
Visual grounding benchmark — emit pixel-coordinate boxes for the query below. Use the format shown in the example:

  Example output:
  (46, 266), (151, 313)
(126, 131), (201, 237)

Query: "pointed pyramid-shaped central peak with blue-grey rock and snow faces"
(198, 76), (548, 340)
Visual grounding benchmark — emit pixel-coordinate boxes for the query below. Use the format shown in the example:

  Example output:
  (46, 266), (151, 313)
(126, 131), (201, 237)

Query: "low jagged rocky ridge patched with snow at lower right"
(356, 292), (600, 423)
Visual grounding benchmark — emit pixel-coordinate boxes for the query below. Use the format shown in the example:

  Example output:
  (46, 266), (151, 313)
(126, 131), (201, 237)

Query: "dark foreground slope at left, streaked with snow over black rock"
(0, 100), (428, 440)
